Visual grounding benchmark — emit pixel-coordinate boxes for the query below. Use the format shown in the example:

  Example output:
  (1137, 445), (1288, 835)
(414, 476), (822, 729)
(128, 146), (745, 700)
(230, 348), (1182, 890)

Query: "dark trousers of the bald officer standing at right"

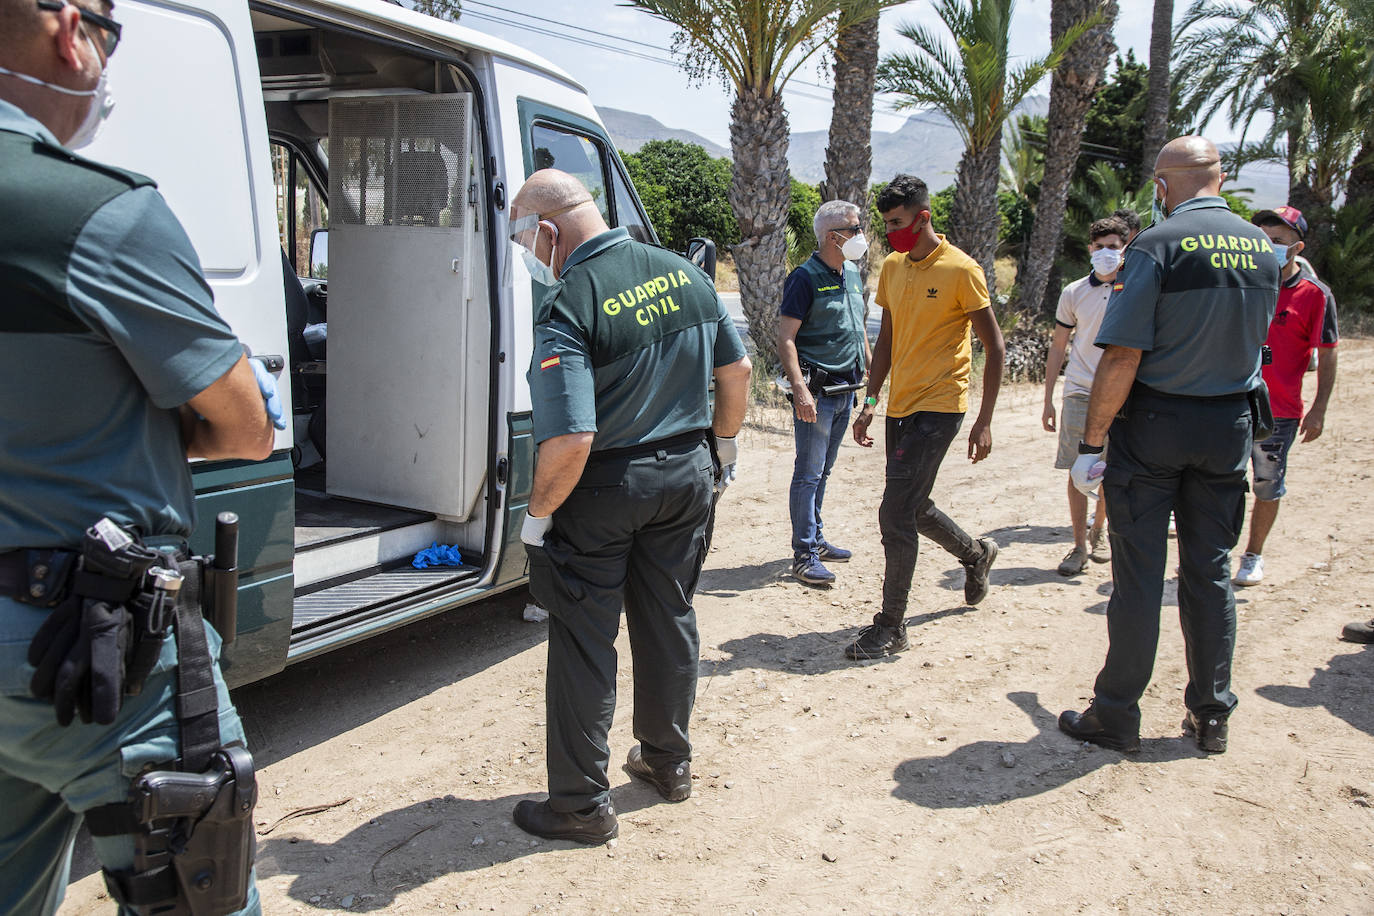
(1094, 385), (1250, 733)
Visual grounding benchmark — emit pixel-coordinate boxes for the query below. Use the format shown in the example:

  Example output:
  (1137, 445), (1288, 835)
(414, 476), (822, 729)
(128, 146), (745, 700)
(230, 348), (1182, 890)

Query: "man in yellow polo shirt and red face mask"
(845, 174), (1006, 659)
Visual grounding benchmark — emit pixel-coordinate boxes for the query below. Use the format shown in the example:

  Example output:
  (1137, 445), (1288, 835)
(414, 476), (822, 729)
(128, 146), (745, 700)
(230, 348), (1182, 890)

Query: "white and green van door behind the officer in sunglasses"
(82, 0), (294, 683)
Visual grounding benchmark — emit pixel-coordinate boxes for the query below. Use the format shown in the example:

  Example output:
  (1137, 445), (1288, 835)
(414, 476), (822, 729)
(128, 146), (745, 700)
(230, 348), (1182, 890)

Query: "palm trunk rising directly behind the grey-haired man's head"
(820, 16), (878, 283)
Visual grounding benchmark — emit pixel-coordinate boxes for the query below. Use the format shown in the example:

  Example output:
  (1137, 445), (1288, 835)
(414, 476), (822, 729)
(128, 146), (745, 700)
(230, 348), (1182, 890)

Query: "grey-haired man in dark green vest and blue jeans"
(778, 201), (870, 585)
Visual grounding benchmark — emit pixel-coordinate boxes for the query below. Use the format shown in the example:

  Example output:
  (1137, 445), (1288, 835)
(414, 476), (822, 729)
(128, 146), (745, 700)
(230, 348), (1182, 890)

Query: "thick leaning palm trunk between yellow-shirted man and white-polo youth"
(1017, 0), (1117, 314)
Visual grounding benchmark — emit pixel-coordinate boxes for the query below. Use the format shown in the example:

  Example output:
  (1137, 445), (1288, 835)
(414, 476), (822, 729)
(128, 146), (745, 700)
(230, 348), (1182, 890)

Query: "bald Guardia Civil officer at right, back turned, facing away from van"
(1059, 136), (1279, 753)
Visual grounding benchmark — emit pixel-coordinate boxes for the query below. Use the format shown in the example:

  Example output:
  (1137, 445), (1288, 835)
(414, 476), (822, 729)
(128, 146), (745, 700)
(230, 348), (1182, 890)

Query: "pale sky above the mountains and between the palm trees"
(463, 0), (1264, 147)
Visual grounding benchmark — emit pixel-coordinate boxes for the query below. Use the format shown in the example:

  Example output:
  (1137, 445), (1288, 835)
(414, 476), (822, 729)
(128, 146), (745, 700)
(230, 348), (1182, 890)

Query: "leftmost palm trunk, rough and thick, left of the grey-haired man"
(730, 87), (791, 375)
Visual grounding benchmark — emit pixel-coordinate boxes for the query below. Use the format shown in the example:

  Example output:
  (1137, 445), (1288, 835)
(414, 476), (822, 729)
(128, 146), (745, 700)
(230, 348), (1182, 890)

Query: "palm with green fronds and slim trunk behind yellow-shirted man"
(878, 0), (1084, 293)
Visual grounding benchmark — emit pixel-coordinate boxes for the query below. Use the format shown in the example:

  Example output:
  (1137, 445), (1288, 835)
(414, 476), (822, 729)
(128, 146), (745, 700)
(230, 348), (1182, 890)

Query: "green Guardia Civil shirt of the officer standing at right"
(1096, 198), (1279, 397)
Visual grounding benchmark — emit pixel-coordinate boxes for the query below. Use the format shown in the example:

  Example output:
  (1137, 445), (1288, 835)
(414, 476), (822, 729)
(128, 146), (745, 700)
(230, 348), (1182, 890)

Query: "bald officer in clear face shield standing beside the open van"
(511, 169), (749, 843)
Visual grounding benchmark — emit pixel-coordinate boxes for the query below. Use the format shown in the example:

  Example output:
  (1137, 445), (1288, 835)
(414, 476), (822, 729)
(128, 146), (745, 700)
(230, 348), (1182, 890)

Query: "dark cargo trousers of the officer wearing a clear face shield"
(529, 441), (714, 812)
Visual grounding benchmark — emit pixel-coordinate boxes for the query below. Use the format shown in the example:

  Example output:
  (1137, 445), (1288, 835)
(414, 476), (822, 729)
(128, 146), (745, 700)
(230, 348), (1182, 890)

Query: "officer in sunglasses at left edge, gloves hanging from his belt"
(0, 0), (280, 915)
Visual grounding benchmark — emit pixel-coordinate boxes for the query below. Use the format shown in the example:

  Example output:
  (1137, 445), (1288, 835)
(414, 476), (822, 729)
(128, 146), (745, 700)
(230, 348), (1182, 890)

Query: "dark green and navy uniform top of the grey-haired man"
(779, 253), (867, 382)
